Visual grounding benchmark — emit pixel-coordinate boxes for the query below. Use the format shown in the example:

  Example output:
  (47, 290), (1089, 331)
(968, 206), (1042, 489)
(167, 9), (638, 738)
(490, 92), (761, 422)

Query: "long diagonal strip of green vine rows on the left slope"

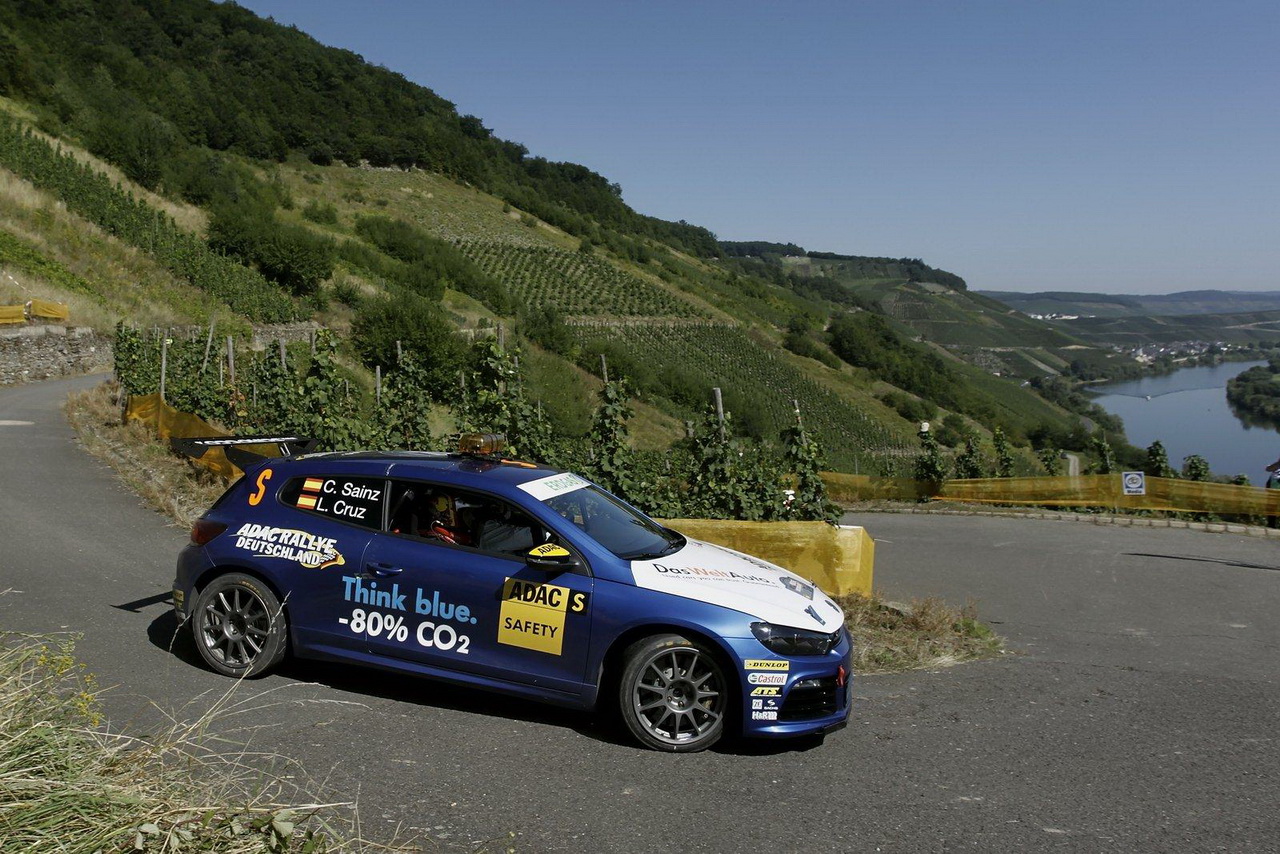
(0, 117), (297, 323)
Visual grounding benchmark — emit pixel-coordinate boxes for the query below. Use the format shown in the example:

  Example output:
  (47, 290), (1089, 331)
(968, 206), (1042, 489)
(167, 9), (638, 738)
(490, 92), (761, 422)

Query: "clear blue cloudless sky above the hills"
(241, 0), (1280, 293)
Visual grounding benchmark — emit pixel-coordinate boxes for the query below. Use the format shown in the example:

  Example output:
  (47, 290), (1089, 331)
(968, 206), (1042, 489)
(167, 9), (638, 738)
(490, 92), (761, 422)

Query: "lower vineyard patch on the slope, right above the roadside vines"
(575, 321), (916, 474)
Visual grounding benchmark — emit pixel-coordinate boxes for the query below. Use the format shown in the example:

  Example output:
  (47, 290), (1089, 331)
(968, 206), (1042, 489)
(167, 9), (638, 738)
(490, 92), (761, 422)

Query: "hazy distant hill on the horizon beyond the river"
(979, 291), (1280, 318)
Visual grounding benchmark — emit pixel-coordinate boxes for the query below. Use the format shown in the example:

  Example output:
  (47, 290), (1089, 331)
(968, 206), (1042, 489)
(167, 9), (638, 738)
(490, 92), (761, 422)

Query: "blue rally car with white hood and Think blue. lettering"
(173, 437), (851, 752)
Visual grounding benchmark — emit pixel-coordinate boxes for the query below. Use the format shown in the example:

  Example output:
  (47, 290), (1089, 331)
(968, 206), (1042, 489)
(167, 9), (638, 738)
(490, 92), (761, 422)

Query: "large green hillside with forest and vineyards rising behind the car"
(0, 0), (1111, 472)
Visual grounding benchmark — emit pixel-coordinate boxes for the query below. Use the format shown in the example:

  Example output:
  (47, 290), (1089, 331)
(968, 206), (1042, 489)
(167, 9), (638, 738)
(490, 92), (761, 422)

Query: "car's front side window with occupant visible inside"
(389, 480), (552, 556)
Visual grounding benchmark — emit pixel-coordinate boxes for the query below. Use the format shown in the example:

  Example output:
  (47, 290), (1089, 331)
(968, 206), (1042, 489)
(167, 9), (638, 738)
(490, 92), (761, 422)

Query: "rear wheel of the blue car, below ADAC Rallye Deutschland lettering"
(191, 572), (288, 679)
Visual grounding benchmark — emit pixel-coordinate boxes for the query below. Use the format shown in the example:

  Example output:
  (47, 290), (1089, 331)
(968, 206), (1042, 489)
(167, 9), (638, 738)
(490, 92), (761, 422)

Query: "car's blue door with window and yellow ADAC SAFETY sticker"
(365, 479), (593, 694)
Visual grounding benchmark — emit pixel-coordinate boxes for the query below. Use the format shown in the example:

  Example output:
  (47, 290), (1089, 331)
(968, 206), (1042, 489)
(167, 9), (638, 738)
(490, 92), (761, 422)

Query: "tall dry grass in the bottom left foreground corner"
(0, 632), (408, 854)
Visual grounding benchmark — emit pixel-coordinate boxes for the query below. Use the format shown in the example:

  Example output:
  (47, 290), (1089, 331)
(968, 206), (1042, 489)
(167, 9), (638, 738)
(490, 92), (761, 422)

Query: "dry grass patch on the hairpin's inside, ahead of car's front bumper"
(836, 593), (1005, 673)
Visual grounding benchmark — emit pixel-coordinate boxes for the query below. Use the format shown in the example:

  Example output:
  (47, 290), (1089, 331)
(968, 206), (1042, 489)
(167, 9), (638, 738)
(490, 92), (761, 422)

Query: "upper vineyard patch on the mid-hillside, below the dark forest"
(458, 241), (707, 318)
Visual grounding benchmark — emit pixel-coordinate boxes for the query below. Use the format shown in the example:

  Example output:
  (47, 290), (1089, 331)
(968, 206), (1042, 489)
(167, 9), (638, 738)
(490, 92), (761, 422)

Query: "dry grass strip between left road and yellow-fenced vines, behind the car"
(67, 383), (227, 528)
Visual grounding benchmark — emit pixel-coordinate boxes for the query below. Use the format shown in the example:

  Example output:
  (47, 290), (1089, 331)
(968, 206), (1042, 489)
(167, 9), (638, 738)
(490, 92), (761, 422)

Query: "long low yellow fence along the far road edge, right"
(822, 471), (1280, 516)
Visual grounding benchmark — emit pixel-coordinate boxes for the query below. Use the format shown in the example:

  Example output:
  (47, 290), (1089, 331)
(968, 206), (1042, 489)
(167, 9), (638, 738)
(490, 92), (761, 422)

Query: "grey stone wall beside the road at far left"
(0, 325), (111, 385)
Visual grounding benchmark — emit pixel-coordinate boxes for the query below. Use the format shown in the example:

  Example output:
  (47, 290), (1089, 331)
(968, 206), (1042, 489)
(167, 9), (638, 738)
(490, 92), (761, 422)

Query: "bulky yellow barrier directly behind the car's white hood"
(662, 519), (876, 595)
